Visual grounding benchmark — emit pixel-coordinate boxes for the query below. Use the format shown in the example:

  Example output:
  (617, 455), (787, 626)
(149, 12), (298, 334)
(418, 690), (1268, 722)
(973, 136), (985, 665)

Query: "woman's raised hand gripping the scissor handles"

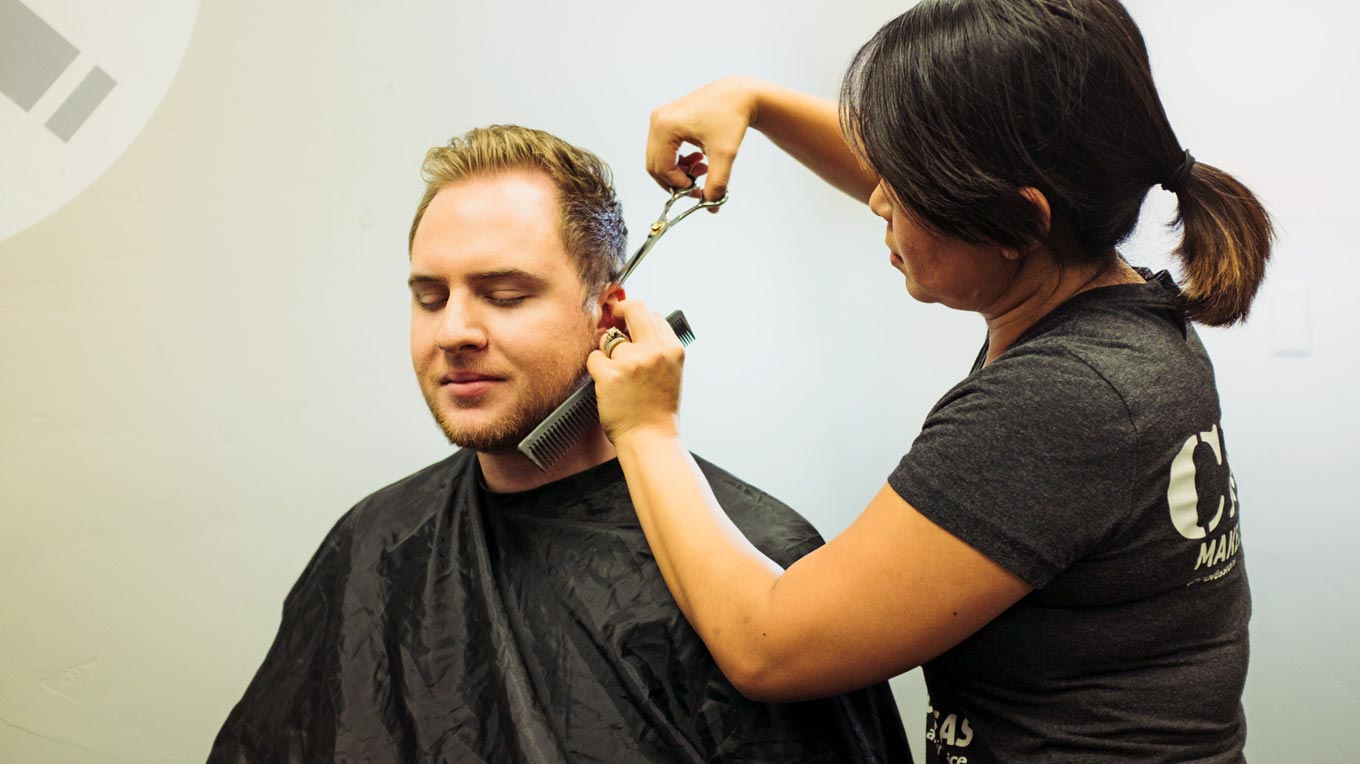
(647, 77), (760, 205)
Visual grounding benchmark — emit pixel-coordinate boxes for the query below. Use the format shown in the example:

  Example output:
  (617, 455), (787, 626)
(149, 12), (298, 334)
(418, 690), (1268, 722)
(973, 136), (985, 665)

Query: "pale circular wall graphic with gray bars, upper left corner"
(0, 0), (199, 241)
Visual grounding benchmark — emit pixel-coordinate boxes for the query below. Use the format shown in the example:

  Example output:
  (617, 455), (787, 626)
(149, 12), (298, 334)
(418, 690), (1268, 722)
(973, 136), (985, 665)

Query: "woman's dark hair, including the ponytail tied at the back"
(840, 0), (1273, 326)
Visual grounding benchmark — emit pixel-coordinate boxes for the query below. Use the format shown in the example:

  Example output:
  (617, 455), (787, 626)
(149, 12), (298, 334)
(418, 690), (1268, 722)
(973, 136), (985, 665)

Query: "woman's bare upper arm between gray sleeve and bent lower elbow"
(738, 485), (1032, 700)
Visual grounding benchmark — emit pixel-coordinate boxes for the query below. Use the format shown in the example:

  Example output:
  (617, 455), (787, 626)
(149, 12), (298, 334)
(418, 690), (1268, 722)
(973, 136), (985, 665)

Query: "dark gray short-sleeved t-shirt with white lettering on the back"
(888, 273), (1251, 764)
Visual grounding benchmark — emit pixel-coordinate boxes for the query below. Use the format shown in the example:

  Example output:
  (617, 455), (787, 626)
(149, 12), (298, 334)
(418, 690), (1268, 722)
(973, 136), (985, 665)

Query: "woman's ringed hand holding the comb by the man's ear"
(586, 300), (684, 445)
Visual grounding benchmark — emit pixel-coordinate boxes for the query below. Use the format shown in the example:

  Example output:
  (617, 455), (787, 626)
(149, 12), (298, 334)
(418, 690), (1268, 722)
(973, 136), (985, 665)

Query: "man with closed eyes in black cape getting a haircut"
(209, 126), (910, 763)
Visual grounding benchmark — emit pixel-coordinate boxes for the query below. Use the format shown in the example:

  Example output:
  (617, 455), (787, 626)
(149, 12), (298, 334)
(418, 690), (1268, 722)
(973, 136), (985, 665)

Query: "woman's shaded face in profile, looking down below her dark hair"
(869, 181), (1017, 314)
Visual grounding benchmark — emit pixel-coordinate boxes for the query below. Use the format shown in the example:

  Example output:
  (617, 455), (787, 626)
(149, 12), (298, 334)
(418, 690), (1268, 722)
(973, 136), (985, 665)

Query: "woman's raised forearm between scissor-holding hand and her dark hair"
(745, 77), (879, 203)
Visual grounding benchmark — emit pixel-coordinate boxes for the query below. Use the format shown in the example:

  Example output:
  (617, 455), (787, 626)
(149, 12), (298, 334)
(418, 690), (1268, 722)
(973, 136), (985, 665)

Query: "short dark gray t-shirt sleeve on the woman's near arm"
(888, 348), (1138, 589)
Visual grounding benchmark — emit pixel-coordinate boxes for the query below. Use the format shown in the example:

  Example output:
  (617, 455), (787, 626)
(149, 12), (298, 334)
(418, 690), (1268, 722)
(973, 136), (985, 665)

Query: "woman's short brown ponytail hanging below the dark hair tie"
(1171, 156), (1274, 326)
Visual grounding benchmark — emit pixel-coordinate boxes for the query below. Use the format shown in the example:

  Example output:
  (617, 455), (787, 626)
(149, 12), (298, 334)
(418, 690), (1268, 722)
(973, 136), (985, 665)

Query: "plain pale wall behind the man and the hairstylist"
(0, 0), (1360, 764)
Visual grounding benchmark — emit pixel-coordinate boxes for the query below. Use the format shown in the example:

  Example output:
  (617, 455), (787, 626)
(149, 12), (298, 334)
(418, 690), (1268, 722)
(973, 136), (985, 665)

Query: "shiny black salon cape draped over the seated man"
(208, 451), (911, 764)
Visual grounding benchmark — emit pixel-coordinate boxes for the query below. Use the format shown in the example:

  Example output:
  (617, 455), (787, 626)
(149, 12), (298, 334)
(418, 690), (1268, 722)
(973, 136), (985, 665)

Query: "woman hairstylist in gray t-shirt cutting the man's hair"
(589, 0), (1272, 764)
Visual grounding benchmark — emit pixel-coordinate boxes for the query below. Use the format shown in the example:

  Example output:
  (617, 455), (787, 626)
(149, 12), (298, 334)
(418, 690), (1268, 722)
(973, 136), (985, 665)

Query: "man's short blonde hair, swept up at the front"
(407, 125), (628, 294)
